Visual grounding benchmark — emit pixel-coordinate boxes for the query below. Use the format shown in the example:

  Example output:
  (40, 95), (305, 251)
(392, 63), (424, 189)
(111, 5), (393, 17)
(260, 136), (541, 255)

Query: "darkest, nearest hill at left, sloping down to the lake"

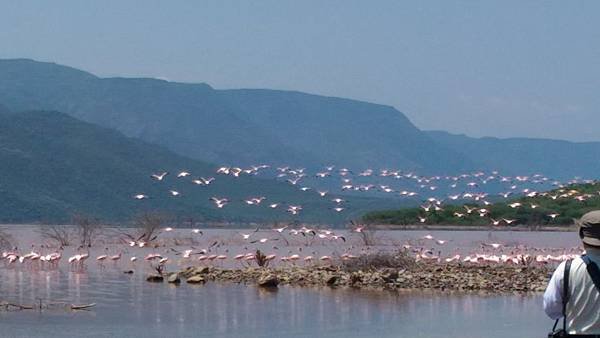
(0, 111), (398, 223)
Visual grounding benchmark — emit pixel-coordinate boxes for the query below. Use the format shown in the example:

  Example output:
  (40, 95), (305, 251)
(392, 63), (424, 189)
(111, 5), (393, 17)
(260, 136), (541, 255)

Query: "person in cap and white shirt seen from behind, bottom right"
(544, 211), (600, 335)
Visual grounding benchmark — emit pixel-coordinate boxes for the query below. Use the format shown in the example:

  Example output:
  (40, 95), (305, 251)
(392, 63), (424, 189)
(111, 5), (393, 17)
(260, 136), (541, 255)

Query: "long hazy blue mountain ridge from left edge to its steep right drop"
(0, 59), (477, 173)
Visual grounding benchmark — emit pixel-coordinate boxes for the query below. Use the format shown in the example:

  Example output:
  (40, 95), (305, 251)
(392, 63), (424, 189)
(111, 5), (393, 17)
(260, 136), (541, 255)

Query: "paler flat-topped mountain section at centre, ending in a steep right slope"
(219, 89), (470, 172)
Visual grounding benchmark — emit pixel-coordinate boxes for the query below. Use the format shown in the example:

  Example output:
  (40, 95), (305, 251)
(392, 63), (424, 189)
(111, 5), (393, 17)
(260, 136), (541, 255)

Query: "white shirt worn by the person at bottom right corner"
(544, 249), (600, 334)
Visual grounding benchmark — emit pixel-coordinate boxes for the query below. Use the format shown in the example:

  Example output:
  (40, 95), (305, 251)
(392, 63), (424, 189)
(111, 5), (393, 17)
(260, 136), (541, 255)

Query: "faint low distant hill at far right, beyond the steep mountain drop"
(427, 131), (600, 179)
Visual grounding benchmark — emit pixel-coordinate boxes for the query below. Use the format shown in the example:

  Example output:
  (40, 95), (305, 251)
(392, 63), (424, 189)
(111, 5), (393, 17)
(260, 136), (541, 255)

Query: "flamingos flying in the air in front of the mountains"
(133, 165), (594, 226)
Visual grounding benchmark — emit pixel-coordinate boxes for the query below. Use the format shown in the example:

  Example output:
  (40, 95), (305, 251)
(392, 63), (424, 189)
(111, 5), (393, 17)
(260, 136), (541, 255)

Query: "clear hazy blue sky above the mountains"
(0, 0), (600, 141)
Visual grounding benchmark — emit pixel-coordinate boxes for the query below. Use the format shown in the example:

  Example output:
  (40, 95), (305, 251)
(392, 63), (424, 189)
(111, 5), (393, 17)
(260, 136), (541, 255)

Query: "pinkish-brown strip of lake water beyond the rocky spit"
(2, 225), (581, 269)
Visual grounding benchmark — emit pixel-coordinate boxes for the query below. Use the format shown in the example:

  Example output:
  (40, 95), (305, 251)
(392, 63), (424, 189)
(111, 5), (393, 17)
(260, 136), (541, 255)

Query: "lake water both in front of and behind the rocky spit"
(0, 227), (578, 338)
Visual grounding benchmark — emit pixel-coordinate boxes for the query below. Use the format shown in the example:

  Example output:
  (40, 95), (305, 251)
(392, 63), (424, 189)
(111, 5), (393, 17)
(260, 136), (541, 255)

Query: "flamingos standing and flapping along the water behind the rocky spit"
(2, 226), (583, 271)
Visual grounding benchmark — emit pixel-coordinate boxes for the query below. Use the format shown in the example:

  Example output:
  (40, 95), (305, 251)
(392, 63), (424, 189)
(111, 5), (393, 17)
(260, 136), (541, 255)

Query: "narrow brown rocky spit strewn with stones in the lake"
(147, 264), (551, 293)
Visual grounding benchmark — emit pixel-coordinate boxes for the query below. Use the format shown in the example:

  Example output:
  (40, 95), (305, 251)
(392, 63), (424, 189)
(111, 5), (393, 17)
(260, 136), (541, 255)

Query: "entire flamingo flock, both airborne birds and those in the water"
(1, 165), (593, 270)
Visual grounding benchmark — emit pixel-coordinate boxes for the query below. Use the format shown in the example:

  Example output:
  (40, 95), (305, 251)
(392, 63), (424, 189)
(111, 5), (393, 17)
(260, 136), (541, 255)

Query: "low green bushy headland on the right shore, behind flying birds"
(363, 182), (600, 226)
